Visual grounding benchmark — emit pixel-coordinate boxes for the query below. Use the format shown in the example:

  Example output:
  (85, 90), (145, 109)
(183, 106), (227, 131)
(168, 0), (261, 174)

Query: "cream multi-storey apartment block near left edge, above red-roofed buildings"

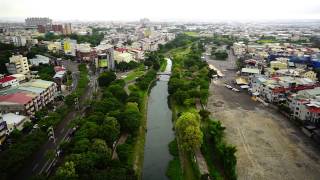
(6, 55), (30, 74)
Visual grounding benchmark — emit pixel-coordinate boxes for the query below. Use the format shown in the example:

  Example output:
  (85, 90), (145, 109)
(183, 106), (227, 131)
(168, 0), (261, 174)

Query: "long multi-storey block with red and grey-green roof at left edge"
(0, 79), (57, 115)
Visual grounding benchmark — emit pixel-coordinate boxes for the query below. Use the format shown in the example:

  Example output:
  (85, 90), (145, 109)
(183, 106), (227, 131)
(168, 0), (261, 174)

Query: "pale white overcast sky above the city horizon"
(0, 0), (320, 21)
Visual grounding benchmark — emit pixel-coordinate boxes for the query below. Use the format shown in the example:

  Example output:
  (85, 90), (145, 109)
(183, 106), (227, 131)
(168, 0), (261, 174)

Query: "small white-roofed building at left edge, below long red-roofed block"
(2, 113), (30, 134)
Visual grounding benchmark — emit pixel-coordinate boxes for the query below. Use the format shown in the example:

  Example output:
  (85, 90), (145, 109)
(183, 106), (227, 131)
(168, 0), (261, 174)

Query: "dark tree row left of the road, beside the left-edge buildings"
(0, 64), (88, 179)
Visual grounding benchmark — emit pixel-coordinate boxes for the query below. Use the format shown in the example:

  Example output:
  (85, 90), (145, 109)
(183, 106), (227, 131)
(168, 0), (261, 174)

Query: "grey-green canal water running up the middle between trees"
(142, 59), (174, 180)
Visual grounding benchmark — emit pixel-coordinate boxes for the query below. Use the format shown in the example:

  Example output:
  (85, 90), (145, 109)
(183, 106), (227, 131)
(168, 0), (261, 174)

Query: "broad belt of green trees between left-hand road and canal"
(53, 60), (156, 179)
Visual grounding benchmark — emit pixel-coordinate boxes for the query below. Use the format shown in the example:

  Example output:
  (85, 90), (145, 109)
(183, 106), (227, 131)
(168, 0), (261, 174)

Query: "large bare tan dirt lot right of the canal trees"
(207, 51), (320, 180)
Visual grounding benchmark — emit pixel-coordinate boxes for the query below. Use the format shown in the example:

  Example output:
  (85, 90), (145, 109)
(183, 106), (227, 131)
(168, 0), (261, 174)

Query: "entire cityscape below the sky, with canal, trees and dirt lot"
(0, 17), (320, 180)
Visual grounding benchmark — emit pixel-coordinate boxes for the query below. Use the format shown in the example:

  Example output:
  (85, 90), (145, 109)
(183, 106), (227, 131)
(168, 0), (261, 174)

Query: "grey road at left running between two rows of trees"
(15, 63), (98, 179)
